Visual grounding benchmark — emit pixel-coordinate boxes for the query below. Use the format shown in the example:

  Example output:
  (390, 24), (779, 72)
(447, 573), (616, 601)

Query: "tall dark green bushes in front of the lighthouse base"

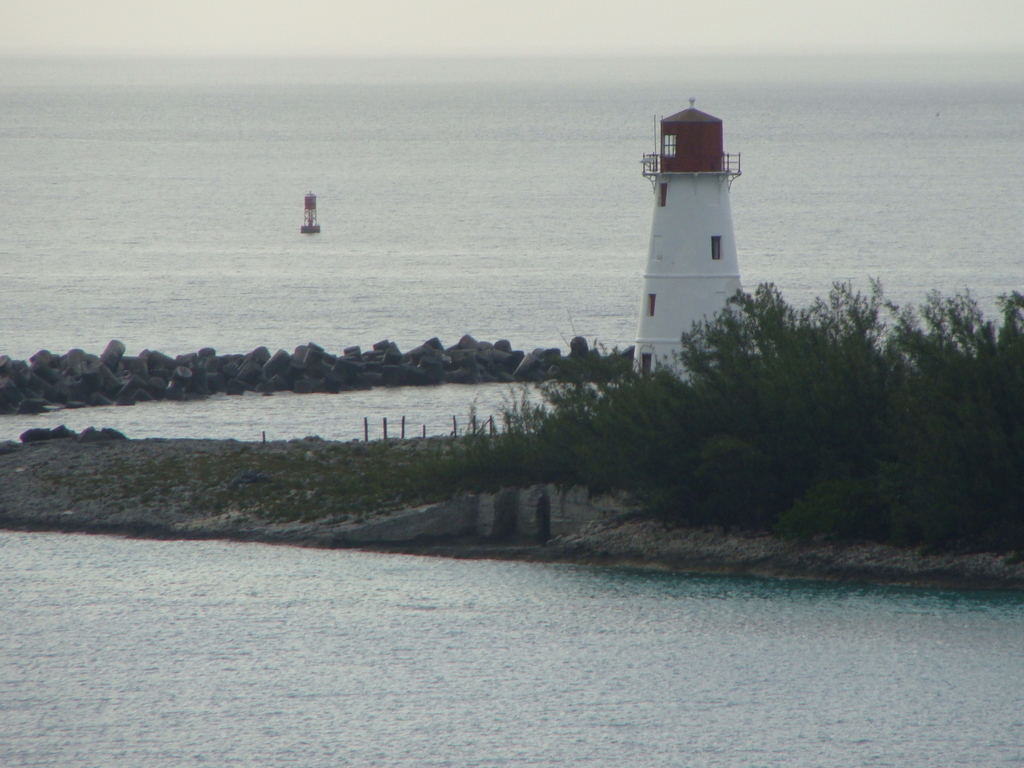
(440, 285), (1024, 551)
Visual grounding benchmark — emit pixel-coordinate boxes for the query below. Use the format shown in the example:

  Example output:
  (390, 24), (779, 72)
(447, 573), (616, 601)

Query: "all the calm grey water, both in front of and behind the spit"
(0, 60), (1024, 768)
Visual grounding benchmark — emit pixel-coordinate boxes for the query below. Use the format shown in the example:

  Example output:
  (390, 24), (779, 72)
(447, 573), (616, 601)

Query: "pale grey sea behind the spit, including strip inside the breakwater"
(0, 59), (1024, 439)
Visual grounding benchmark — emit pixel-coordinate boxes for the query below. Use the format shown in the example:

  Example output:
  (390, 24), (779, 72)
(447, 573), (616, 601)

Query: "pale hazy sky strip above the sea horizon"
(0, 0), (1024, 56)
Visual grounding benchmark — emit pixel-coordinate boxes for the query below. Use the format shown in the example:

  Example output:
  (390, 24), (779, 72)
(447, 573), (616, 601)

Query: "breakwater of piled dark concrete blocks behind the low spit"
(0, 335), (591, 414)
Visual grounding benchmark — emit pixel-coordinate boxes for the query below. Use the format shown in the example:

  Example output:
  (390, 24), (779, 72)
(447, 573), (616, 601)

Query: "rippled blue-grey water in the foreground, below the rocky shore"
(0, 532), (1024, 768)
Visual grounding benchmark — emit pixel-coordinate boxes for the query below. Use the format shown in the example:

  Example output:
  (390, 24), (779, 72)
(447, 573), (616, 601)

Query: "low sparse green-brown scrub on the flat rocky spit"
(44, 437), (452, 522)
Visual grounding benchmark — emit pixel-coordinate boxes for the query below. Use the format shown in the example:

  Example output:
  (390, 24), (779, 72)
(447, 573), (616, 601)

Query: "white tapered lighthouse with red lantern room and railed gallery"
(634, 98), (739, 372)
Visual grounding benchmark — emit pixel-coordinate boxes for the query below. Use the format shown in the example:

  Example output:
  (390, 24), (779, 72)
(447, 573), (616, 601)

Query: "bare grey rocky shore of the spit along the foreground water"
(0, 430), (1024, 591)
